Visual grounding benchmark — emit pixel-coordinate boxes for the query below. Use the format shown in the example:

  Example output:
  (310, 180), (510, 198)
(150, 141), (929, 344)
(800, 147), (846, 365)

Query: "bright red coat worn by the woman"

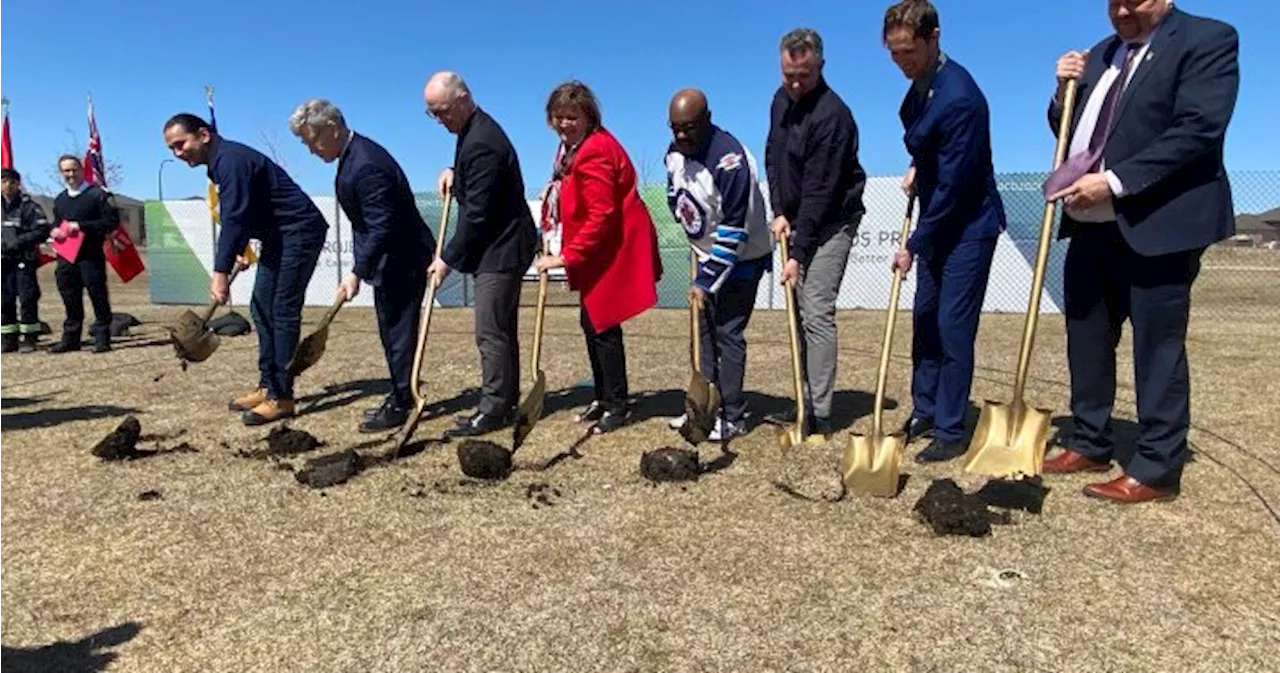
(559, 128), (662, 333)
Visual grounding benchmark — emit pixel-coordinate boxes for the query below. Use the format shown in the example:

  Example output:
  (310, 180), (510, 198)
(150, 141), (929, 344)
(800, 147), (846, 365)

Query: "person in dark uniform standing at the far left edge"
(0, 169), (52, 353)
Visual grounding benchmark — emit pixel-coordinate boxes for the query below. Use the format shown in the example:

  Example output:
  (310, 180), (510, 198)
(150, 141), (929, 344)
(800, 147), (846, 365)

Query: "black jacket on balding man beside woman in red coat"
(443, 107), (539, 274)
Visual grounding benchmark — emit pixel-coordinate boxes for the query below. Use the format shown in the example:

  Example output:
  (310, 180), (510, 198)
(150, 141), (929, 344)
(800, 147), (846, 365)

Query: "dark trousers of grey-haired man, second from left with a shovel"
(374, 267), (426, 406)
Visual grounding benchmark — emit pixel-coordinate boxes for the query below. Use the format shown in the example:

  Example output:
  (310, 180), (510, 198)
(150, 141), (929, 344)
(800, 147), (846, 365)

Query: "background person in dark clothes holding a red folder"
(49, 155), (120, 353)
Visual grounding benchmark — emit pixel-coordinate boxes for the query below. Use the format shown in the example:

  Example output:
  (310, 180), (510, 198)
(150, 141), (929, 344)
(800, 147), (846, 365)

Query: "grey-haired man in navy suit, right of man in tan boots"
(289, 99), (435, 432)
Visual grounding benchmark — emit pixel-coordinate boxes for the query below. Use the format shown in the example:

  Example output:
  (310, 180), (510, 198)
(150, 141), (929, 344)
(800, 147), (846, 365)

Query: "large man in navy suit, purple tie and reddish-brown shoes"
(1044, 0), (1240, 503)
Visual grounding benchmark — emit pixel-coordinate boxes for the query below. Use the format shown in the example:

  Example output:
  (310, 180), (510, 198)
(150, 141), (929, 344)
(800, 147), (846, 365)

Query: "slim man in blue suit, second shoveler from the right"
(883, 0), (1005, 463)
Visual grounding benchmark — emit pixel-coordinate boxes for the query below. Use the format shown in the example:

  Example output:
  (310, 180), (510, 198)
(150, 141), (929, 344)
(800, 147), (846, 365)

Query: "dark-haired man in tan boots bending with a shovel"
(164, 113), (329, 425)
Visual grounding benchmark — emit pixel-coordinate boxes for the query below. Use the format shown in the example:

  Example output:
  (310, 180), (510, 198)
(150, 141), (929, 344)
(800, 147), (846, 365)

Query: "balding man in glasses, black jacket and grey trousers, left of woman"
(422, 72), (538, 436)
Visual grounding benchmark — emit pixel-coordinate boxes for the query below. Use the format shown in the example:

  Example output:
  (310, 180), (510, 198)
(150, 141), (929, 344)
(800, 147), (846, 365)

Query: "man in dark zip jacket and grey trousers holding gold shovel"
(764, 28), (867, 435)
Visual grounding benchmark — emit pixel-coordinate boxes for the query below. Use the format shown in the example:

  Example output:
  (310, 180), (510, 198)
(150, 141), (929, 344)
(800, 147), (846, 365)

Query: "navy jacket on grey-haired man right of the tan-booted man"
(334, 133), (435, 287)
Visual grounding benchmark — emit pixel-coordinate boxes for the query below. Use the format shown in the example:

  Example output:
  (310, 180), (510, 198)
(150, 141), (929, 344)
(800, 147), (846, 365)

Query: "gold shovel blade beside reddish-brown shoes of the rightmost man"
(964, 400), (1051, 479)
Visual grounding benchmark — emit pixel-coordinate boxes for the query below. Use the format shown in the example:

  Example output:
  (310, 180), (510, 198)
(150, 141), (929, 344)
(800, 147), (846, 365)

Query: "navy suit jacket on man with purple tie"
(1048, 8), (1240, 256)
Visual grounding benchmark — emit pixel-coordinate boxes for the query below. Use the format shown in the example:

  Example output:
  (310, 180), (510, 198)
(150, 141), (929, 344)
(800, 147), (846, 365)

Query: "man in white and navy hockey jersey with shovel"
(667, 88), (773, 441)
